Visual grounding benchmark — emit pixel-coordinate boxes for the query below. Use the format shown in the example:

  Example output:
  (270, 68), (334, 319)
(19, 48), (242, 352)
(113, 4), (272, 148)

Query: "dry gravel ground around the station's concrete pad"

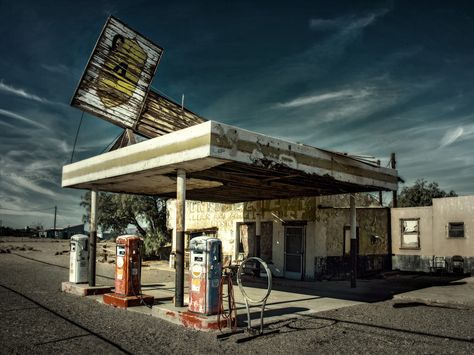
(0, 238), (474, 355)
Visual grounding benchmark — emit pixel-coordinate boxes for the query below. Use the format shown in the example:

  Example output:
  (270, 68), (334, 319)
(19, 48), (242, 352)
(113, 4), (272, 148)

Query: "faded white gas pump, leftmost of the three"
(69, 234), (89, 283)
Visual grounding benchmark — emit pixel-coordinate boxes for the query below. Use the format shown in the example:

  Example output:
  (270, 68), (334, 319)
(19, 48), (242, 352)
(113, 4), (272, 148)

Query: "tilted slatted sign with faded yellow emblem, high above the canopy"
(71, 17), (163, 128)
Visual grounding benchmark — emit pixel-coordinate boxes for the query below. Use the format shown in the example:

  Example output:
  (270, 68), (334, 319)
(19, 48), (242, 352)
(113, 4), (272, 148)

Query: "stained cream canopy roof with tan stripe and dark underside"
(62, 121), (398, 203)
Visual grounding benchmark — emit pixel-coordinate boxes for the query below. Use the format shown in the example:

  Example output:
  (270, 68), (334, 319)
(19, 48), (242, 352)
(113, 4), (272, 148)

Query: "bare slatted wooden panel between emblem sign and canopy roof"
(137, 91), (206, 138)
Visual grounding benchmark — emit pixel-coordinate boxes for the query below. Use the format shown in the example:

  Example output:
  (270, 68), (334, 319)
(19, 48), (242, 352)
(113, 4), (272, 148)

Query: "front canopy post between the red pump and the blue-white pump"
(174, 169), (186, 307)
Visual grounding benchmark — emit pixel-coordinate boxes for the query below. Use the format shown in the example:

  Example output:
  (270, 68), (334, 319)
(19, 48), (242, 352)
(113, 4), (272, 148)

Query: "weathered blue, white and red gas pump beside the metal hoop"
(188, 236), (222, 315)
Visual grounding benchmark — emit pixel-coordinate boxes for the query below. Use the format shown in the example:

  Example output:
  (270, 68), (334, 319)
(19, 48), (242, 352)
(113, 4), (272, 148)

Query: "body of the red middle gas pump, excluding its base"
(115, 235), (143, 296)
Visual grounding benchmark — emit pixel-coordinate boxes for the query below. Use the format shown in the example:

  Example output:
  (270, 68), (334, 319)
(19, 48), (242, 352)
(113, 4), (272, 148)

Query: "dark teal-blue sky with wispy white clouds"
(0, 0), (474, 227)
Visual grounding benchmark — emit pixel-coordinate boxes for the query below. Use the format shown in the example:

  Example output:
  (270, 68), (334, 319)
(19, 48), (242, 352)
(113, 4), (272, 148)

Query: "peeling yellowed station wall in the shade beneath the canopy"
(167, 195), (389, 280)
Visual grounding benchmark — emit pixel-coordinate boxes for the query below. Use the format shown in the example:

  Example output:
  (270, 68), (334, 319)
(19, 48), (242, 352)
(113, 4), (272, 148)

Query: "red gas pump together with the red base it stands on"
(103, 235), (153, 308)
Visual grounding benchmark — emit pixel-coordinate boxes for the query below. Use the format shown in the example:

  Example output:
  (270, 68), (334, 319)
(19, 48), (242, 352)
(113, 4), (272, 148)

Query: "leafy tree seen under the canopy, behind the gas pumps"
(81, 192), (171, 256)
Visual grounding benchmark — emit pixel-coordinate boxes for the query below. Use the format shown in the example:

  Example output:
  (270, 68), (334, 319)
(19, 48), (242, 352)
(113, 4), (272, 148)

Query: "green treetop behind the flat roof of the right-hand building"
(398, 179), (457, 207)
